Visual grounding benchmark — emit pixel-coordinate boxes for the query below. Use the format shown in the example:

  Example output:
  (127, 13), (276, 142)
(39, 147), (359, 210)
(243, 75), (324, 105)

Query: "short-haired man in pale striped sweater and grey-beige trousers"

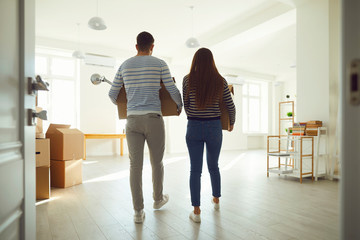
(109, 32), (182, 223)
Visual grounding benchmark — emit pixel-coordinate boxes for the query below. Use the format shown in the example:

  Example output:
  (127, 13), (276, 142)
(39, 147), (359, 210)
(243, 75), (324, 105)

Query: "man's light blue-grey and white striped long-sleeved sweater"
(109, 56), (182, 116)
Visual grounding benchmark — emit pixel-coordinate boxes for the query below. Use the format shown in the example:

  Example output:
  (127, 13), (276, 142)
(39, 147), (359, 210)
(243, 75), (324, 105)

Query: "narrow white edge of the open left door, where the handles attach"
(18, 0), (36, 240)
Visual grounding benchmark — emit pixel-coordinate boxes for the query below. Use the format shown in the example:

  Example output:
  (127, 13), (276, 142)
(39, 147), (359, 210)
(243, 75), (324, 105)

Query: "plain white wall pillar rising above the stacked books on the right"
(296, 0), (330, 124)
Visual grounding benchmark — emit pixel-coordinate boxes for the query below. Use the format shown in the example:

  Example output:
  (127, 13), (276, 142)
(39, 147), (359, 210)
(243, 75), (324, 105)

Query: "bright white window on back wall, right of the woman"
(242, 81), (268, 133)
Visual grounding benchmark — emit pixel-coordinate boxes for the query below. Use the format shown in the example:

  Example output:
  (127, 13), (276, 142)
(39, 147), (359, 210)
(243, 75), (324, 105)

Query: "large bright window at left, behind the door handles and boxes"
(35, 49), (79, 129)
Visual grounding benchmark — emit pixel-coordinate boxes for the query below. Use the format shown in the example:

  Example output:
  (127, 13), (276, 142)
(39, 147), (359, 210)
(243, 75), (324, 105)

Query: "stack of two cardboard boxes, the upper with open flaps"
(46, 124), (84, 188)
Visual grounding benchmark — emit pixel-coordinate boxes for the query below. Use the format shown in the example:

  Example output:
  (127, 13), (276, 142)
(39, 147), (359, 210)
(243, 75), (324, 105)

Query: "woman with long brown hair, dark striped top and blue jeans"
(183, 48), (235, 222)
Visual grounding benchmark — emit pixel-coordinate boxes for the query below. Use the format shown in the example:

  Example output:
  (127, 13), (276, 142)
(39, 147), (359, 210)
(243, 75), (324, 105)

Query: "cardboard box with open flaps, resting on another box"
(46, 124), (84, 160)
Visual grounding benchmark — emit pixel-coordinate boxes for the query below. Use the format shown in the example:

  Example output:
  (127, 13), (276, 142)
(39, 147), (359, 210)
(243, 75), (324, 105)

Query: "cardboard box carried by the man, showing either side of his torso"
(116, 78), (179, 119)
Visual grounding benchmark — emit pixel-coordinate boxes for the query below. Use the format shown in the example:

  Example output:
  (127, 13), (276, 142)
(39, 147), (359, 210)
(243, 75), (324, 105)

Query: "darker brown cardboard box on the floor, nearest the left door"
(36, 167), (50, 200)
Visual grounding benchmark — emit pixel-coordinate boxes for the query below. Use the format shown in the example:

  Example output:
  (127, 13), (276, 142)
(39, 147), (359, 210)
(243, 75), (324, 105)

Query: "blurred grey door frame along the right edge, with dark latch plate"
(340, 0), (360, 240)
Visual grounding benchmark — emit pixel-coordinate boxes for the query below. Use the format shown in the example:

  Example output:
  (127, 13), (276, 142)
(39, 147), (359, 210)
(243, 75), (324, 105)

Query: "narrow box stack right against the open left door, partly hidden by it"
(35, 107), (50, 200)
